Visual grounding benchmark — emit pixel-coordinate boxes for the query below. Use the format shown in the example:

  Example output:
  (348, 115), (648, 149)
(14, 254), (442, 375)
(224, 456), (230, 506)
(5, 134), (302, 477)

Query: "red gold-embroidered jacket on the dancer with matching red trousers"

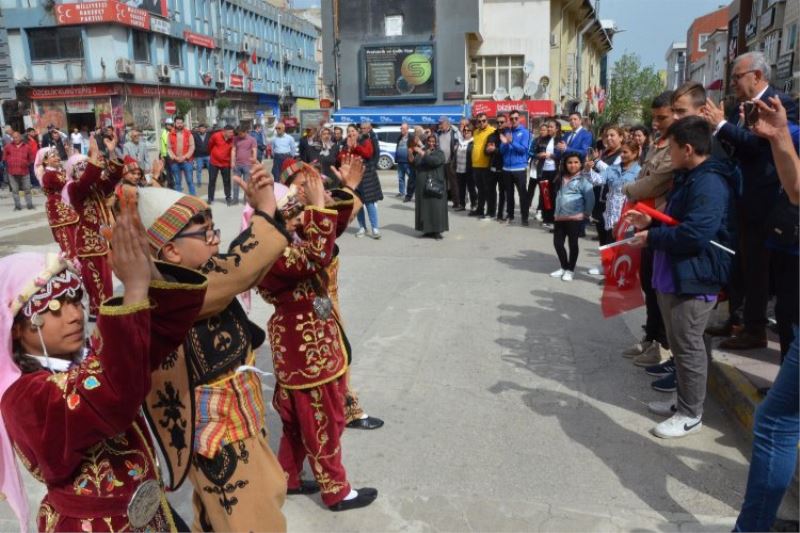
(257, 207), (347, 389)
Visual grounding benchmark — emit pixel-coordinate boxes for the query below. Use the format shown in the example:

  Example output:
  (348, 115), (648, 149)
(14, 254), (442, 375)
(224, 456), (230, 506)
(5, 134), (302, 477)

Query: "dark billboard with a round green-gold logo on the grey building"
(361, 43), (436, 100)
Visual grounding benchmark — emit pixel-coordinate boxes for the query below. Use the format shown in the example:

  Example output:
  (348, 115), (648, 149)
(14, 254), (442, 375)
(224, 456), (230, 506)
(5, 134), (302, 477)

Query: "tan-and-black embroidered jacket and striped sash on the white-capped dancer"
(145, 211), (288, 490)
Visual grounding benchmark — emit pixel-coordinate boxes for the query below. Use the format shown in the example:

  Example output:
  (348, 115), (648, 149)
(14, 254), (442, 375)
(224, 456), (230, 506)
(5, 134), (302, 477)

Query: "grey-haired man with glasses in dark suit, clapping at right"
(704, 48), (797, 350)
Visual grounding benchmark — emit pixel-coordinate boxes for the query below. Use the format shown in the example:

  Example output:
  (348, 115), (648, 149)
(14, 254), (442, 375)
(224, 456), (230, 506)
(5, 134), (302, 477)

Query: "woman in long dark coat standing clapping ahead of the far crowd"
(412, 135), (449, 240)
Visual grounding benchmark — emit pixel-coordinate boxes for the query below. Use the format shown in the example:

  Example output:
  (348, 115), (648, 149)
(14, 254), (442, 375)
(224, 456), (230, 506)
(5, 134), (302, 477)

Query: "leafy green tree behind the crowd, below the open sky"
(595, 54), (665, 128)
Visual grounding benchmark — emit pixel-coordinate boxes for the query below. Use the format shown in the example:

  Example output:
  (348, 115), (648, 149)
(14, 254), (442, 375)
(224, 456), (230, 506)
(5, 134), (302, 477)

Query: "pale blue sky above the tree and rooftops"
(293, 0), (730, 70)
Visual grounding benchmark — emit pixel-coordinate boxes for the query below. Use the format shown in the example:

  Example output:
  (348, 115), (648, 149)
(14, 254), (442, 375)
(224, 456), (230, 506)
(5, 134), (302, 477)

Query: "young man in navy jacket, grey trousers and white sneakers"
(626, 116), (736, 439)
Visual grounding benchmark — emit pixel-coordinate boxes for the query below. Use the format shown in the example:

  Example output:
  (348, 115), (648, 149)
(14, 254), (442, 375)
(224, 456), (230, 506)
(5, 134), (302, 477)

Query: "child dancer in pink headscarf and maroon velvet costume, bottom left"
(0, 197), (206, 531)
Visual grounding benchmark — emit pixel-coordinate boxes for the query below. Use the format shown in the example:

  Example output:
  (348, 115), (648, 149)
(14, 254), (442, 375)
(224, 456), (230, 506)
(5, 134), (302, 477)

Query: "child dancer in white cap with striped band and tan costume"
(138, 165), (289, 531)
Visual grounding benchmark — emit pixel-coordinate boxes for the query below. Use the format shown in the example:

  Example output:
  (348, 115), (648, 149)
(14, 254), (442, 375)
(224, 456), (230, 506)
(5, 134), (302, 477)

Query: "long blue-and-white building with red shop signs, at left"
(0, 0), (317, 140)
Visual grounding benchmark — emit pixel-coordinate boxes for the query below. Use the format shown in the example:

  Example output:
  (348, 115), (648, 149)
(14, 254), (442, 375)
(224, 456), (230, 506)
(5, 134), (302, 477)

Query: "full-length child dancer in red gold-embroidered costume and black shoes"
(258, 165), (378, 511)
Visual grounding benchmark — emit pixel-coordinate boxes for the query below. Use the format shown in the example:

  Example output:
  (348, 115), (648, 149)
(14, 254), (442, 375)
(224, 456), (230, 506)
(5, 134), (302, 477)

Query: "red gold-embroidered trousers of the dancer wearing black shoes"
(272, 377), (350, 505)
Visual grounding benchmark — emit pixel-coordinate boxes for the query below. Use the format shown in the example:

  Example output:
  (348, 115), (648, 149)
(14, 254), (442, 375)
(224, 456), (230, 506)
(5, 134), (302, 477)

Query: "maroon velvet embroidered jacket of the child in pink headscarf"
(0, 265), (206, 531)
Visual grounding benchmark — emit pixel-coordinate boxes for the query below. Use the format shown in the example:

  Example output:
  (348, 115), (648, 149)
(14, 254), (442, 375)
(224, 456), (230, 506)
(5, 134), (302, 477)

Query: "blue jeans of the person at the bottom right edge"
(734, 324), (800, 531)
